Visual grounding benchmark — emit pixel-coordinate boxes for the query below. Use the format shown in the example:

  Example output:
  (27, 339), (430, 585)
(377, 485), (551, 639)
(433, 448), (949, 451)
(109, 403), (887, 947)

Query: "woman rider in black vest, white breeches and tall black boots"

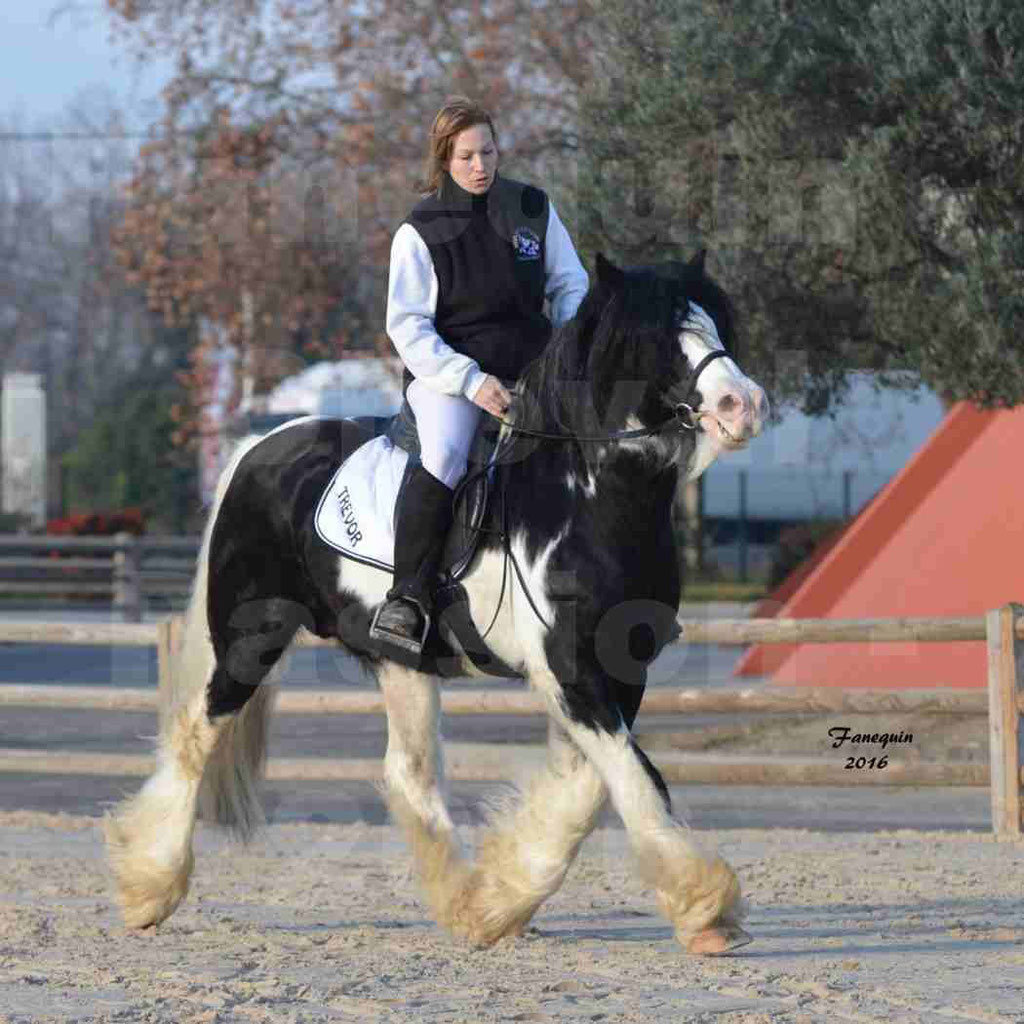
(370, 96), (588, 657)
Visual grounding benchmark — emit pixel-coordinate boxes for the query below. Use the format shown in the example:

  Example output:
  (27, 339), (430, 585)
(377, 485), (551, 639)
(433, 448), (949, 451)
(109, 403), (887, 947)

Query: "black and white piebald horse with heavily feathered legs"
(106, 255), (767, 954)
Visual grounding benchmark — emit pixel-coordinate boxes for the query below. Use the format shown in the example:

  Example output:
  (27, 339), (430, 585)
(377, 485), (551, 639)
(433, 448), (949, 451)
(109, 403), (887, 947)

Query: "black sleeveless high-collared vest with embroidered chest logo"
(406, 173), (551, 383)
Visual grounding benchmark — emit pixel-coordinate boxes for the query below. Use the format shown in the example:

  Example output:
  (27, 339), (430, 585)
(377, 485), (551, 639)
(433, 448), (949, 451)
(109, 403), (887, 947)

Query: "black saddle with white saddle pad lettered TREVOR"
(313, 401), (521, 679)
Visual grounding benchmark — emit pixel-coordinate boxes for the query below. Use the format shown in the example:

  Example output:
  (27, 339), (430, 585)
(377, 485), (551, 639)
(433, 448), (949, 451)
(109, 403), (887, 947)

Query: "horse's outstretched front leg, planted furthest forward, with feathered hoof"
(539, 668), (750, 954)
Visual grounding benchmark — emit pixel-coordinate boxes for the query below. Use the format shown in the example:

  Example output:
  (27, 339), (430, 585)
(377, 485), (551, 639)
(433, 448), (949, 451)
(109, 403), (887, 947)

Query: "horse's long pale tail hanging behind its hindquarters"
(161, 438), (276, 839)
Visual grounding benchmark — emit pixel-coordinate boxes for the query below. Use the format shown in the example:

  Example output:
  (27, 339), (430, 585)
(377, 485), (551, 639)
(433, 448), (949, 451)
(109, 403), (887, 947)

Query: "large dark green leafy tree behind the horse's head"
(581, 0), (1024, 412)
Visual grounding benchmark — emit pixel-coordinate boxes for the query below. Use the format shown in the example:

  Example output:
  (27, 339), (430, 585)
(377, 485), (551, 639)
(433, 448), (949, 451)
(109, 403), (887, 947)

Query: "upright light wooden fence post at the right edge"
(985, 604), (1024, 840)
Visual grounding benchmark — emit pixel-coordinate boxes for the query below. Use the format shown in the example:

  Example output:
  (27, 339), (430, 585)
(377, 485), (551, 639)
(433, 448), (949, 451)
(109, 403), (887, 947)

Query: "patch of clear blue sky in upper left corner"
(0, 0), (164, 130)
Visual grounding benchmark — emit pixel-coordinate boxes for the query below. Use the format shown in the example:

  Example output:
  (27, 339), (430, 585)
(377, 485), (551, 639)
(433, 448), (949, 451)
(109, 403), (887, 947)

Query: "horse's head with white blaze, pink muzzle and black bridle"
(597, 252), (768, 478)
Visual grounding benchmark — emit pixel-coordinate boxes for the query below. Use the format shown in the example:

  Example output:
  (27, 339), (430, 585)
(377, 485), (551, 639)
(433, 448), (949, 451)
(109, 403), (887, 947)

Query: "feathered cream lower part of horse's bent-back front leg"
(456, 722), (607, 944)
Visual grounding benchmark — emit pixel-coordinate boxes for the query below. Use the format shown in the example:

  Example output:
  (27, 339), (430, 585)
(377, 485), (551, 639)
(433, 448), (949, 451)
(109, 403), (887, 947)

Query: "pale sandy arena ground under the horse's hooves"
(0, 812), (1024, 1024)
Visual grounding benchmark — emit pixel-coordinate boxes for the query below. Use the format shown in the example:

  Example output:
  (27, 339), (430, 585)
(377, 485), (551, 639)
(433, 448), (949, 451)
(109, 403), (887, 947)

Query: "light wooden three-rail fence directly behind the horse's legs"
(0, 604), (1024, 839)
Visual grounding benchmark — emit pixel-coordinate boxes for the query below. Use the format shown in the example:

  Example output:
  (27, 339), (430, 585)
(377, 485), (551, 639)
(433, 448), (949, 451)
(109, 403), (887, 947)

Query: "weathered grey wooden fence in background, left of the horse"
(0, 534), (200, 623)
